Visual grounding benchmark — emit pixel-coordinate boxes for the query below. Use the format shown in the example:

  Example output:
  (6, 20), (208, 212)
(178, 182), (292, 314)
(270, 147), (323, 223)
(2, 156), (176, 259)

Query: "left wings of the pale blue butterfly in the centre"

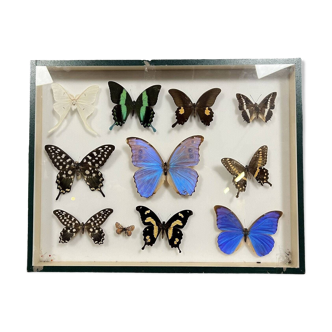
(127, 137), (165, 198)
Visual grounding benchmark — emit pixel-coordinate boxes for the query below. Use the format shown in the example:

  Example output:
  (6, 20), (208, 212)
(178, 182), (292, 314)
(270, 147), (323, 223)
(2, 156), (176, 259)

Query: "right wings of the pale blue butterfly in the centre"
(167, 135), (204, 195)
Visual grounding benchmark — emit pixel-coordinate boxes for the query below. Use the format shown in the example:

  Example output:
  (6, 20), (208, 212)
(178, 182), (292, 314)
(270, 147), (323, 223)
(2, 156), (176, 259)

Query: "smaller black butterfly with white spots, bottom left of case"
(53, 209), (113, 244)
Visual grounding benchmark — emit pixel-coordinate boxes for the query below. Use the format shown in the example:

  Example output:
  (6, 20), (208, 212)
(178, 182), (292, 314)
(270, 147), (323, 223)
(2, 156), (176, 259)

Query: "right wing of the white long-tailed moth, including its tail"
(76, 85), (99, 135)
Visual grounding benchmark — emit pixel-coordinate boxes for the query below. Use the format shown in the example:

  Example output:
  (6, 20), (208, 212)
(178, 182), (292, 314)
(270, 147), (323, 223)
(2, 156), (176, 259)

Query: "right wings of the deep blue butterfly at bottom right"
(248, 211), (282, 256)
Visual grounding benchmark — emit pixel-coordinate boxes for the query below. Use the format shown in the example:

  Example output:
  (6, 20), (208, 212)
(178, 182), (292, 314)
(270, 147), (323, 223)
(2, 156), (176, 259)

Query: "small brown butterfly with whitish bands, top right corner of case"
(236, 92), (277, 123)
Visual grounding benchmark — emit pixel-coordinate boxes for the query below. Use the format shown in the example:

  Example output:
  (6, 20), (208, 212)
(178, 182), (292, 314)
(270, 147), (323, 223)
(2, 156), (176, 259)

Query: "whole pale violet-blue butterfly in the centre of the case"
(127, 135), (204, 198)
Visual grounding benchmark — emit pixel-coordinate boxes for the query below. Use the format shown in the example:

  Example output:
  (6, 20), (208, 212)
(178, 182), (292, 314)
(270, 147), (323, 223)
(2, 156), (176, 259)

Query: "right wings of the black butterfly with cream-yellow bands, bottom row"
(165, 210), (193, 252)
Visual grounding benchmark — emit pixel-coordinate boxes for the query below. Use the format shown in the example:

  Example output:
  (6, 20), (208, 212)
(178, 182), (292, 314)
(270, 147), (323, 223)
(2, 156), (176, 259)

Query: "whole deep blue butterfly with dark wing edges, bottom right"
(214, 205), (283, 257)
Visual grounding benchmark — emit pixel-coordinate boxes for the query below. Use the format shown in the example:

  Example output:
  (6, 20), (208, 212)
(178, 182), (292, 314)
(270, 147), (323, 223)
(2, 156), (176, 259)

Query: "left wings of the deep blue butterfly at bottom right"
(214, 205), (244, 255)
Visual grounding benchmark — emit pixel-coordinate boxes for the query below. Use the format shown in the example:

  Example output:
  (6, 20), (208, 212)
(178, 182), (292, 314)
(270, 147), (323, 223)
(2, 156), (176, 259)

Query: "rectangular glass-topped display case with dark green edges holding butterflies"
(27, 57), (306, 274)
